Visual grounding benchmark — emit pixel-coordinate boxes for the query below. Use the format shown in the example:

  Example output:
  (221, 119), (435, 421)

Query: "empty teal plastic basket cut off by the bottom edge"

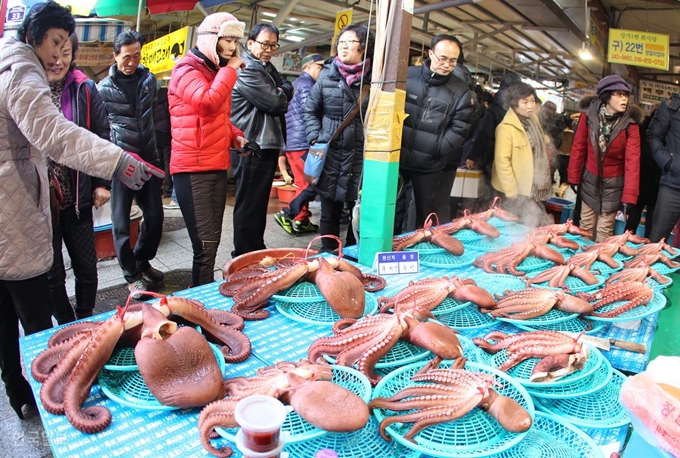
(495, 412), (604, 458)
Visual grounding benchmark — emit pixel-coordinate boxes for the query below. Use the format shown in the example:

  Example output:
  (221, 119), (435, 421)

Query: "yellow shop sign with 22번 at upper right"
(607, 29), (669, 70)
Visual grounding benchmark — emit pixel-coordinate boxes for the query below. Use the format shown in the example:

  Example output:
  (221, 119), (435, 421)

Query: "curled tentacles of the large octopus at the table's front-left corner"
(31, 292), (251, 434)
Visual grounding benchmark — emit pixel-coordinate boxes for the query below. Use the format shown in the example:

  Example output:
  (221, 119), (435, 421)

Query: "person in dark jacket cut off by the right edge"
(647, 94), (680, 242)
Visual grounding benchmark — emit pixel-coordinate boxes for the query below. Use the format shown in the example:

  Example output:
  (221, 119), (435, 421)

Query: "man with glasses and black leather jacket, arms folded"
(231, 24), (293, 257)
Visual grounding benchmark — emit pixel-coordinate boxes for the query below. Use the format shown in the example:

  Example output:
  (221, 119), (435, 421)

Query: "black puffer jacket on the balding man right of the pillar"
(400, 60), (473, 173)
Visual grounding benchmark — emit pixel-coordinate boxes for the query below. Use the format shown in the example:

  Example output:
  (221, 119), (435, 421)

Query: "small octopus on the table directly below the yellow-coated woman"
(474, 241), (564, 277)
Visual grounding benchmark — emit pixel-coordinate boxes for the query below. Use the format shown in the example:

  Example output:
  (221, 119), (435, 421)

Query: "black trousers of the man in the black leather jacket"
(231, 149), (279, 257)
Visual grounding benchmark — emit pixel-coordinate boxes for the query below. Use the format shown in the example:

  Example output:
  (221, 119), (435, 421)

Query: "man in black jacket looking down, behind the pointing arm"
(99, 30), (163, 298)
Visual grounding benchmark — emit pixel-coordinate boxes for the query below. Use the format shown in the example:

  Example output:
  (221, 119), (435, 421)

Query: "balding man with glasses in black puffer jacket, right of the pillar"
(395, 35), (474, 233)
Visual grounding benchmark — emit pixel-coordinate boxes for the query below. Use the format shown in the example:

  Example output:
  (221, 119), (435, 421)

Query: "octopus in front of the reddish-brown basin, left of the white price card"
(219, 250), (386, 320)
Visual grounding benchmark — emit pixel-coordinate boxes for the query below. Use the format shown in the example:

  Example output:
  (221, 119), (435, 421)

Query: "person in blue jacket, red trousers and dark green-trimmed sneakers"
(274, 54), (323, 235)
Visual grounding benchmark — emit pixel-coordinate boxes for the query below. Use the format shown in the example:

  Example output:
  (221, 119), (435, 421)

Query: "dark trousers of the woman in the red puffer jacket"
(172, 170), (227, 286)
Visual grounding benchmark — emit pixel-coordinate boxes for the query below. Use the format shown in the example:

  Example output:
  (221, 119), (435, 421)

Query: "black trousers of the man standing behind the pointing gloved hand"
(111, 176), (163, 283)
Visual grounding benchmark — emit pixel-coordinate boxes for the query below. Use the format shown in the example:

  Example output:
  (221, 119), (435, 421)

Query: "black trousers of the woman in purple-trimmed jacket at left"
(47, 205), (97, 324)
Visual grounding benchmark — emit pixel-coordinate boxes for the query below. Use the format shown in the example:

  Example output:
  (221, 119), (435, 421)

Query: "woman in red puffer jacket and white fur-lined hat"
(168, 13), (247, 286)
